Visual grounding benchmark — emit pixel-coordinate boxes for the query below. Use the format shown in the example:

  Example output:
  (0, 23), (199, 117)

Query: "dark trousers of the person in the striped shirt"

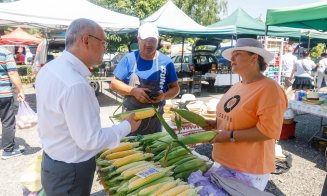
(0, 97), (16, 152)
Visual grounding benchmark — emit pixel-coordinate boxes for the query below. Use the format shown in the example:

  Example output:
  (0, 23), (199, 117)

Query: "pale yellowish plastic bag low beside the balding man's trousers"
(20, 155), (42, 192)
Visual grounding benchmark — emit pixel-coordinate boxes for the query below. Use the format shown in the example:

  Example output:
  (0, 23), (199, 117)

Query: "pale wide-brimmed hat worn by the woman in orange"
(222, 38), (274, 63)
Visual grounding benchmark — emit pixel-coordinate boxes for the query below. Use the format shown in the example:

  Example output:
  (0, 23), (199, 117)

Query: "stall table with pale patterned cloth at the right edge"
(288, 100), (327, 142)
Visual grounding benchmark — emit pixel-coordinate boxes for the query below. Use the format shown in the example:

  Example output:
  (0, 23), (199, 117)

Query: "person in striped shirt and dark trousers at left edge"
(0, 47), (25, 159)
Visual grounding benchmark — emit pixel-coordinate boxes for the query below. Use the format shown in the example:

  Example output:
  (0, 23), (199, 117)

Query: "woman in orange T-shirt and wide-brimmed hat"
(205, 38), (287, 191)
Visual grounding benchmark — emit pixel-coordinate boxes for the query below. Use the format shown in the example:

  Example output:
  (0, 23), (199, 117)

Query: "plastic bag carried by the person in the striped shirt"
(16, 101), (37, 129)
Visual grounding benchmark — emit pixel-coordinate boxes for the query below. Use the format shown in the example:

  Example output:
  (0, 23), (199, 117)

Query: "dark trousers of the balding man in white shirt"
(41, 152), (96, 196)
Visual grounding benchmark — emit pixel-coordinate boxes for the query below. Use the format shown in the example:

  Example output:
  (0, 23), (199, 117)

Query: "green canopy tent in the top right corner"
(266, 1), (327, 31)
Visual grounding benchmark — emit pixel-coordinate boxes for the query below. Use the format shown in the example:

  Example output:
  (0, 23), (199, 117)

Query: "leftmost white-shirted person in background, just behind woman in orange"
(282, 46), (297, 88)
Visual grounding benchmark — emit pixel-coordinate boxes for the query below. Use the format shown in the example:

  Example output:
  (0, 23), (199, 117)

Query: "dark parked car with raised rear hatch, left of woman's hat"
(192, 39), (221, 74)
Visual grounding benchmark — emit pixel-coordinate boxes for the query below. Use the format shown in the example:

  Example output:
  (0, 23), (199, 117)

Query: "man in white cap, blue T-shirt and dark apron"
(111, 23), (179, 134)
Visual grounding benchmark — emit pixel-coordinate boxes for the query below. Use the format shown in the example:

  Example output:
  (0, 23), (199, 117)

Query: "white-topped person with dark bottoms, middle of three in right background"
(290, 52), (316, 90)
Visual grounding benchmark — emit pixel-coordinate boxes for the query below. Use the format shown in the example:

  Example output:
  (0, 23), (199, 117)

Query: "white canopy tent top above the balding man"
(0, 0), (139, 32)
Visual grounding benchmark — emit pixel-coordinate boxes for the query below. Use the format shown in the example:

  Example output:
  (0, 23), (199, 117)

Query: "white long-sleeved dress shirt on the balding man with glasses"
(35, 51), (131, 163)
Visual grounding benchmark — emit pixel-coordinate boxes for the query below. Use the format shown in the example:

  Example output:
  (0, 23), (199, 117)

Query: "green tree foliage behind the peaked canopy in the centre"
(90, 0), (228, 52)
